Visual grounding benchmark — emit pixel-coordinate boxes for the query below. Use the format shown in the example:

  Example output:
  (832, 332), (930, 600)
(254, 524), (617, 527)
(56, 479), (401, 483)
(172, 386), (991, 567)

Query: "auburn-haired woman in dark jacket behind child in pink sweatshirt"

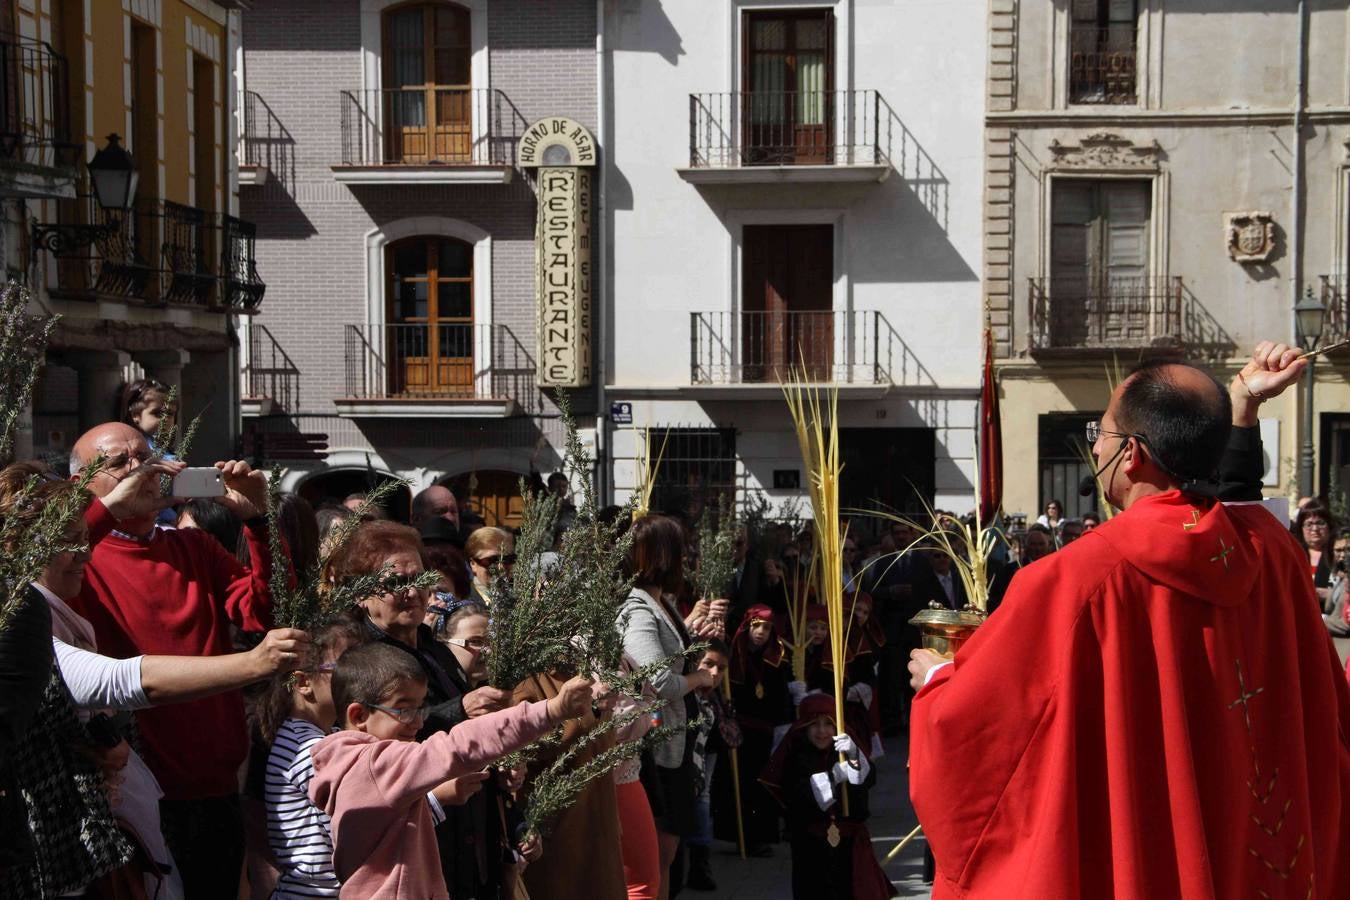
(329, 519), (510, 897)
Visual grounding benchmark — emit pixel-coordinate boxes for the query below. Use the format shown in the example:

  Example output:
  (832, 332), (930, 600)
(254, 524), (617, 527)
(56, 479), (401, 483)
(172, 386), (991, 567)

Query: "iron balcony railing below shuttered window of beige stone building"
(1027, 277), (1185, 351)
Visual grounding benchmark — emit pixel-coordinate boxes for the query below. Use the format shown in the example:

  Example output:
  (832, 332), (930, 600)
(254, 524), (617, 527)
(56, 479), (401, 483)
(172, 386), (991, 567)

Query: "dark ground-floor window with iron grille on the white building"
(652, 428), (736, 518)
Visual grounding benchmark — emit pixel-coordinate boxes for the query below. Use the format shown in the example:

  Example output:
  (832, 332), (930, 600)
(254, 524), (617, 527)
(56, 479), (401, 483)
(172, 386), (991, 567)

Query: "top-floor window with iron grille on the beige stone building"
(1069, 0), (1139, 104)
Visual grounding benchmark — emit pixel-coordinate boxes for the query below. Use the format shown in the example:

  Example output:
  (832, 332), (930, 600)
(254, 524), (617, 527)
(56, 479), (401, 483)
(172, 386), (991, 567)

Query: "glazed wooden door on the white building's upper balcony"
(743, 9), (834, 166)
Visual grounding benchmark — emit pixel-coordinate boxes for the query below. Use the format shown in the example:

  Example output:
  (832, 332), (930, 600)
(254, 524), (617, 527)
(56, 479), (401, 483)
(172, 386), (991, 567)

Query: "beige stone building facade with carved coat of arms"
(981, 0), (1350, 517)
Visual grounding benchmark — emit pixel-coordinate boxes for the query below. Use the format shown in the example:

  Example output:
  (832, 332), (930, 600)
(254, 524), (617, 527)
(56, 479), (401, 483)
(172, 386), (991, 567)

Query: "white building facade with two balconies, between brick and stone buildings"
(598, 0), (987, 513)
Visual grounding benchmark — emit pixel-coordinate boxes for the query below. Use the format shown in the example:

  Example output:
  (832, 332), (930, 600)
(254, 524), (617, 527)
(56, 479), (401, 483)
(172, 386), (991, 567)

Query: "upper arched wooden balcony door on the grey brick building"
(383, 3), (474, 165)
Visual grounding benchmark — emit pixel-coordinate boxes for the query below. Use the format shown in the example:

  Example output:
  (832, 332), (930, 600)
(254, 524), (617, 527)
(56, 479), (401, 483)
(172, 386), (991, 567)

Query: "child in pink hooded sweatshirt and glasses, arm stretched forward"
(309, 644), (591, 900)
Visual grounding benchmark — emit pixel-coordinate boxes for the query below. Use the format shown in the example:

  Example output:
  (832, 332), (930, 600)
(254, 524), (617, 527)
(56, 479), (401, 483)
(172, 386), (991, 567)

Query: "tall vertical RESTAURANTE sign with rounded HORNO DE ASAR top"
(517, 116), (595, 387)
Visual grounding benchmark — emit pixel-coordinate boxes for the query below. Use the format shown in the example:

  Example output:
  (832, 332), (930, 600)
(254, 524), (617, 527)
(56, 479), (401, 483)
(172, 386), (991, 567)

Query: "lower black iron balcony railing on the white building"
(690, 310), (932, 385)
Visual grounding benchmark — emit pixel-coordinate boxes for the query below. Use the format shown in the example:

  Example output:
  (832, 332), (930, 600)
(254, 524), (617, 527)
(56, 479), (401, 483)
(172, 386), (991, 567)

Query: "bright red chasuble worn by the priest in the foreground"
(910, 491), (1350, 900)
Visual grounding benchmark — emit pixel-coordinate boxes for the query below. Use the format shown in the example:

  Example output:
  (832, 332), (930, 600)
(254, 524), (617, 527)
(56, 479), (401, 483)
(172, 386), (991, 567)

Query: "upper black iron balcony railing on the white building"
(689, 90), (895, 169)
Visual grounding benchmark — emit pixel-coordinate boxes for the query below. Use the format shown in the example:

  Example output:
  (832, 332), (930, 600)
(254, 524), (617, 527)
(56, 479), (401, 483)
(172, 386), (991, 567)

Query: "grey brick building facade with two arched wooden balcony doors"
(240, 0), (598, 521)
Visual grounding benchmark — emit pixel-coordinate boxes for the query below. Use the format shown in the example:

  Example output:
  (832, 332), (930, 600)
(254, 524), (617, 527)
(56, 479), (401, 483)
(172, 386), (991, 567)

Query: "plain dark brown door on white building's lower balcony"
(741, 225), (834, 382)
